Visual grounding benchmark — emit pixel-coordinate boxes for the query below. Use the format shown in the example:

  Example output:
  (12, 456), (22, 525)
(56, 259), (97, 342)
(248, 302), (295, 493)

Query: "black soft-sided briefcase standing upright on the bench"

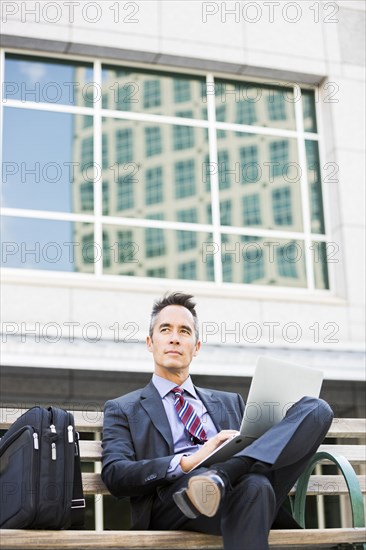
(0, 407), (85, 529)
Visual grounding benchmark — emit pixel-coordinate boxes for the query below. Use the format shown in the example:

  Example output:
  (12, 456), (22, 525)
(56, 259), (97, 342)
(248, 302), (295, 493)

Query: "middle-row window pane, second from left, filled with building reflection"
(103, 117), (211, 223)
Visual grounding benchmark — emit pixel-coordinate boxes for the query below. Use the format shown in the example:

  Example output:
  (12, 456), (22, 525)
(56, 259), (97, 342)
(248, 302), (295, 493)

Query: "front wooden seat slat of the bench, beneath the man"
(0, 527), (366, 550)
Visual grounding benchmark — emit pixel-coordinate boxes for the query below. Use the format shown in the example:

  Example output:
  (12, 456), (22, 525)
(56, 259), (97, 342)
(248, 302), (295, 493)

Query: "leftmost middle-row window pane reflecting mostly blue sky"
(2, 107), (95, 212)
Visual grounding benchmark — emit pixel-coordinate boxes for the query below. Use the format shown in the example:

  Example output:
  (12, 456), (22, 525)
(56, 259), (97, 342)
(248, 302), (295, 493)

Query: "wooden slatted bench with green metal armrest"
(0, 408), (366, 550)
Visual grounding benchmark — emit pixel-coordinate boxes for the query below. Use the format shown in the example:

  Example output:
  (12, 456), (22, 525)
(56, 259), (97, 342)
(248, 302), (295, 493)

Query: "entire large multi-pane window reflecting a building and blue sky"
(1, 54), (331, 290)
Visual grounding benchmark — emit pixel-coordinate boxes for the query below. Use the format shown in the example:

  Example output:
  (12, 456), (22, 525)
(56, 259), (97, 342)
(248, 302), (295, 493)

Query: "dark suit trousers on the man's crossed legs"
(150, 397), (333, 550)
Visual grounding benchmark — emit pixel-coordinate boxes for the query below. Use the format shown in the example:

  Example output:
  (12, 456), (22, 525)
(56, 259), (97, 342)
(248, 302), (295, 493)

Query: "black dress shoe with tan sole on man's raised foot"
(173, 470), (225, 519)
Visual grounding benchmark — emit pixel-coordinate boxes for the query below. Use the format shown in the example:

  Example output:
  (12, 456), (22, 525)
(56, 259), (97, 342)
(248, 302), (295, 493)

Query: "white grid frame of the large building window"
(0, 48), (335, 298)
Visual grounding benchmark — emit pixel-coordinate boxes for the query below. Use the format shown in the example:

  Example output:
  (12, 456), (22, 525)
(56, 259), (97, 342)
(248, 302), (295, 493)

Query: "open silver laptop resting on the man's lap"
(192, 357), (323, 470)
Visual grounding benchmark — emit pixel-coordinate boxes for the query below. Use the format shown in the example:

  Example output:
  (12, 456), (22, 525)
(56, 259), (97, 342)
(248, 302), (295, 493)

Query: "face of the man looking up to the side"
(146, 306), (201, 378)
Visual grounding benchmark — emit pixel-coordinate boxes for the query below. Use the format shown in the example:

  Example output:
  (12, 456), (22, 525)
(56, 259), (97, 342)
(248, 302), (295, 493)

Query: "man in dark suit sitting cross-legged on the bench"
(102, 292), (333, 550)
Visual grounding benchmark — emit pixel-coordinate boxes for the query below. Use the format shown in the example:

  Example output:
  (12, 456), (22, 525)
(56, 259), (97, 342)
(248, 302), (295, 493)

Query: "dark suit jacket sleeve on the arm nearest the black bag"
(102, 400), (174, 497)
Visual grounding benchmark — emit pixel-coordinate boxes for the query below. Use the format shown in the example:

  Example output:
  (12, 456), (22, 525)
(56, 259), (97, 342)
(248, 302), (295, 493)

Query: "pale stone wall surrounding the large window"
(1, 0), (365, 380)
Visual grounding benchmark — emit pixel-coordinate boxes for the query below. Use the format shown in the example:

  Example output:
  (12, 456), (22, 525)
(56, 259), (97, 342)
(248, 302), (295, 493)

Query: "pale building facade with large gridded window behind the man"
(1, 0), (365, 532)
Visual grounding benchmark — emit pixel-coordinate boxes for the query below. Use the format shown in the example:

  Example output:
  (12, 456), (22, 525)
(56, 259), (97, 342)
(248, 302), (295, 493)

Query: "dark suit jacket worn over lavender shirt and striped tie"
(102, 382), (244, 529)
